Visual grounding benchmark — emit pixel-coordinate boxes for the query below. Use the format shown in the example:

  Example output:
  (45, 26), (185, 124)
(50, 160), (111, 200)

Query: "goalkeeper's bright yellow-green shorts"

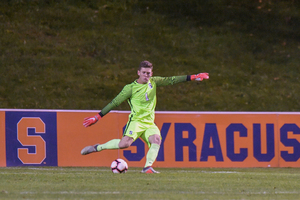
(123, 121), (160, 147)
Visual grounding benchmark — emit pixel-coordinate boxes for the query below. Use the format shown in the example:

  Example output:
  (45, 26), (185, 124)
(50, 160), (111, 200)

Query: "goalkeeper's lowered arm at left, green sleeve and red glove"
(83, 85), (131, 127)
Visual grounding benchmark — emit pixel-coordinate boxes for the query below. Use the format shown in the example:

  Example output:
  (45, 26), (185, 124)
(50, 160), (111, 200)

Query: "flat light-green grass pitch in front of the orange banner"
(0, 167), (300, 199)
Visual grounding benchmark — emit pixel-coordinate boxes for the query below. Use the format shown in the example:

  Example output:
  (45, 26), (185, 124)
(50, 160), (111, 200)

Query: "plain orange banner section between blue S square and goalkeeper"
(57, 112), (122, 166)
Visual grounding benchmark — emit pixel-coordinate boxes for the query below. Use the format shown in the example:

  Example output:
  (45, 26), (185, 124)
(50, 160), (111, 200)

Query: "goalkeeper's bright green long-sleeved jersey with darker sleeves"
(101, 75), (187, 123)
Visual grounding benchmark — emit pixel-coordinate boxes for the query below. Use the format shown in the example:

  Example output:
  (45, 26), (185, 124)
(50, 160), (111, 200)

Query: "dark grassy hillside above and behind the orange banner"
(0, 0), (300, 111)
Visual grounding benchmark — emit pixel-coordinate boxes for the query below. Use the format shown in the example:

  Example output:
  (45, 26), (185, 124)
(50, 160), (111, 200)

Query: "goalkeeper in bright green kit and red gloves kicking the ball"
(81, 61), (209, 173)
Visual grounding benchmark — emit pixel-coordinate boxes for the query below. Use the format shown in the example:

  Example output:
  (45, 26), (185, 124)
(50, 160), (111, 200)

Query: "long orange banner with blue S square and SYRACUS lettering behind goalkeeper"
(0, 109), (300, 167)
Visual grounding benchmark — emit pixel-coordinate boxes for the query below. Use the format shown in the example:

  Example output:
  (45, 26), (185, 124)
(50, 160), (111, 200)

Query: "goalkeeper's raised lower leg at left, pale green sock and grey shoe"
(81, 139), (121, 155)
